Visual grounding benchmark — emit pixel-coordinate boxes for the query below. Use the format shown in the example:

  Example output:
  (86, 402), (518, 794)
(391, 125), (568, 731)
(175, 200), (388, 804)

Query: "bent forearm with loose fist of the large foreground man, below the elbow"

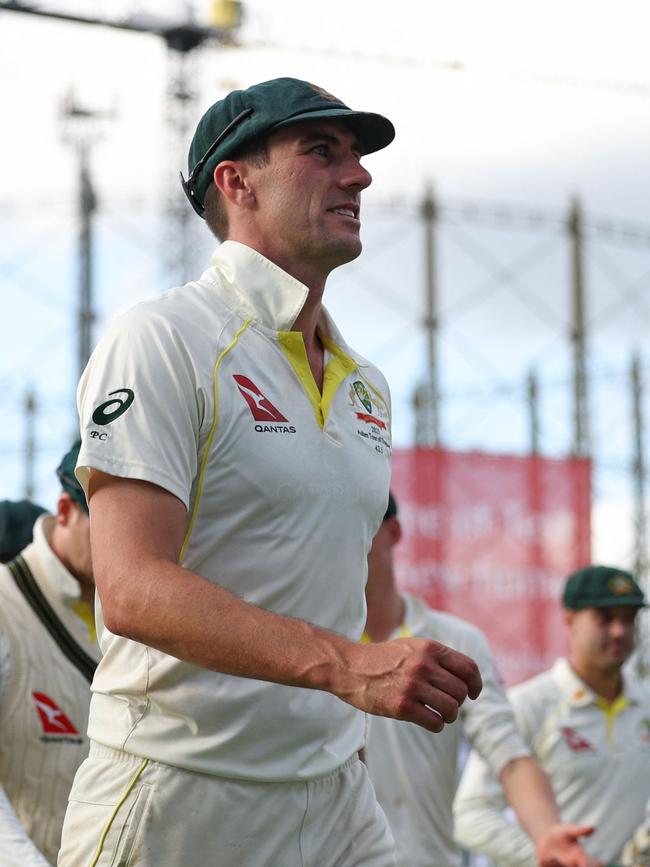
(100, 560), (480, 731)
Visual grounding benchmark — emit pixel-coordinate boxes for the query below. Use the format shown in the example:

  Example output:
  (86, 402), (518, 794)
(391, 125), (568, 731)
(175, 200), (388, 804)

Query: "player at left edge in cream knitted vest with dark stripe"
(0, 443), (99, 867)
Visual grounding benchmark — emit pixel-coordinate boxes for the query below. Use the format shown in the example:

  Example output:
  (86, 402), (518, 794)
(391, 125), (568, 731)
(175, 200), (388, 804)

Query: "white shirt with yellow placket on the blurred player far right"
(454, 659), (650, 867)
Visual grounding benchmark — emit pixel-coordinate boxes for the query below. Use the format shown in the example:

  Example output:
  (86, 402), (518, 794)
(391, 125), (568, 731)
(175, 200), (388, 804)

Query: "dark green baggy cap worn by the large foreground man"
(183, 78), (395, 215)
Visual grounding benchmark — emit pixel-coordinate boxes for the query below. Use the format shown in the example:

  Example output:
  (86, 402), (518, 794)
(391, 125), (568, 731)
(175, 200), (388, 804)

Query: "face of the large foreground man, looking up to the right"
(240, 120), (371, 274)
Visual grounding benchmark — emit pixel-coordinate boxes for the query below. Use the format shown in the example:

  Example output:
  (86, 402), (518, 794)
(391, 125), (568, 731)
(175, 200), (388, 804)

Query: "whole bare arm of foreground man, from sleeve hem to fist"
(89, 471), (481, 732)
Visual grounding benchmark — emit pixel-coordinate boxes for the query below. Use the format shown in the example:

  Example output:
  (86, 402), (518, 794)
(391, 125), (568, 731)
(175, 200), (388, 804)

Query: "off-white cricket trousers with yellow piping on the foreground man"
(57, 743), (395, 867)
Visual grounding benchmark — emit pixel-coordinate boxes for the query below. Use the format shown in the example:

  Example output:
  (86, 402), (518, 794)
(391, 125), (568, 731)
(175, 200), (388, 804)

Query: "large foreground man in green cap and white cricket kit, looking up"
(59, 78), (480, 867)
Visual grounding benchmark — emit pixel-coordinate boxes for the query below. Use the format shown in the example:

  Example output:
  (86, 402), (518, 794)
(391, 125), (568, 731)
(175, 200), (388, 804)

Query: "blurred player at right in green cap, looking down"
(454, 566), (650, 867)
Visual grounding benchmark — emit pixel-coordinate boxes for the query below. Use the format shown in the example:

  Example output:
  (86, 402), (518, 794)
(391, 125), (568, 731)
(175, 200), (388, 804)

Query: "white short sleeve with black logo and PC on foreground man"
(77, 305), (202, 508)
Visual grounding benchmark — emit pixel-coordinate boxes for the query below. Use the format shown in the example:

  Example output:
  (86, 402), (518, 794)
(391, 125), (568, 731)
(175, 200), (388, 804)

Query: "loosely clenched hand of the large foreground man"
(332, 638), (483, 732)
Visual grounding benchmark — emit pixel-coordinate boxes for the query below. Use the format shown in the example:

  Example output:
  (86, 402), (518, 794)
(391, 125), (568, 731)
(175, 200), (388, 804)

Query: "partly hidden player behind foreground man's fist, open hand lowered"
(364, 494), (588, 867)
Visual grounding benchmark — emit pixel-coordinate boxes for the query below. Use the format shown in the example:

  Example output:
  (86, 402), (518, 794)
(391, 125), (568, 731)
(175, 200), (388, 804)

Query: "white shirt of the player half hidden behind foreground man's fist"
(366, 593), (530, 867)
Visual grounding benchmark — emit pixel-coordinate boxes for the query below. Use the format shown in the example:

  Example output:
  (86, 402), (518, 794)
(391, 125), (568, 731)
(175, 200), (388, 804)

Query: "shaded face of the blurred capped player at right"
(566, 605), (638, 673)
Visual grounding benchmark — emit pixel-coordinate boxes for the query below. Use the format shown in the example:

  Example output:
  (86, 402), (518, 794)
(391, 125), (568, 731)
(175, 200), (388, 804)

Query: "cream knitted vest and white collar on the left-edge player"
(0, 515), (99, 865)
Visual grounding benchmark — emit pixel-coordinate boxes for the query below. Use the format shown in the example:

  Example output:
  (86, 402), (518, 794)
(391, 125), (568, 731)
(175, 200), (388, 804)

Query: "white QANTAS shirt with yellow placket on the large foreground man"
(77, 241), (390, 780)
